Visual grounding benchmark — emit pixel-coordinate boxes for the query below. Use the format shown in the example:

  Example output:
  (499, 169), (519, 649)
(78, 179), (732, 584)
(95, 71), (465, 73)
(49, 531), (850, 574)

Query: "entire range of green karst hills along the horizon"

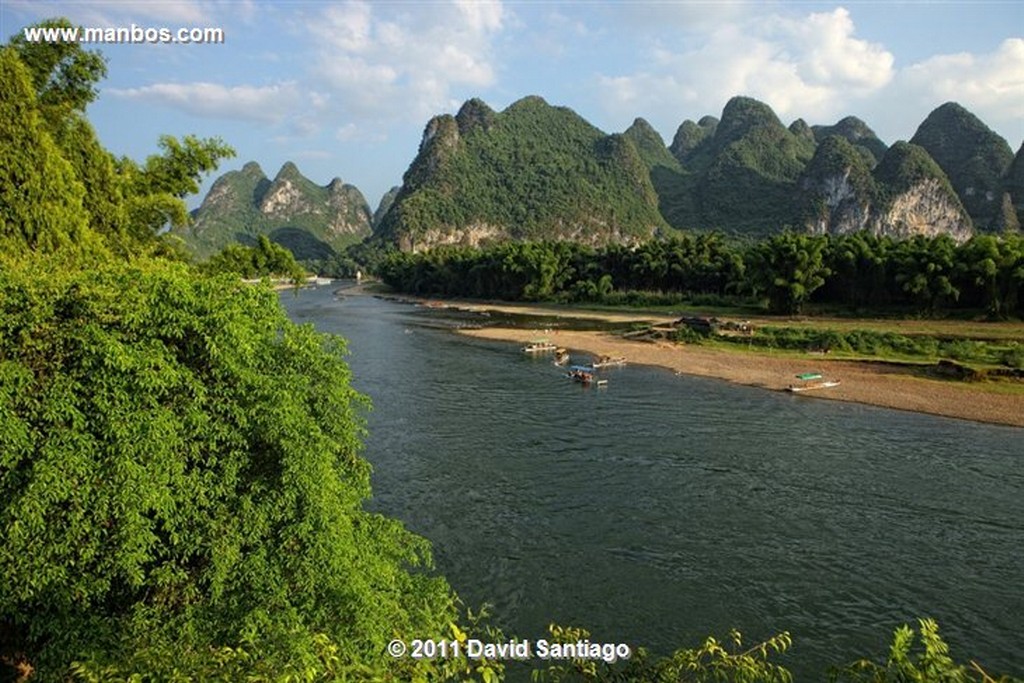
(190, 96), (1024, 255)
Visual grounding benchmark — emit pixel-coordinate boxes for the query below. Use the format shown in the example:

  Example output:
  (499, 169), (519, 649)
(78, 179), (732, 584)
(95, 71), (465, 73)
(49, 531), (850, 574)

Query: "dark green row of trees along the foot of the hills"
(379, 231), (1024, 318)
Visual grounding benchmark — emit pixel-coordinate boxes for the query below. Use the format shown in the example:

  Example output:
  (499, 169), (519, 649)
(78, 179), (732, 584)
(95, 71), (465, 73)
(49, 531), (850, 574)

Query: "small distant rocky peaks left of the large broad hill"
(179, 162), (371, 259)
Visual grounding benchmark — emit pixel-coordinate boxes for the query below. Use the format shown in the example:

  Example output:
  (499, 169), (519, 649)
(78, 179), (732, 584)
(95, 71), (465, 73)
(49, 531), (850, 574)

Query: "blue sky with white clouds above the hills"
(0, 0), (1024, 208)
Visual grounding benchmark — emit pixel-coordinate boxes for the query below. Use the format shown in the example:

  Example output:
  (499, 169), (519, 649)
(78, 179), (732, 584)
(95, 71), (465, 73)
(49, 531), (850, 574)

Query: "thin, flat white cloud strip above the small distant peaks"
(111, 82), (309, 124)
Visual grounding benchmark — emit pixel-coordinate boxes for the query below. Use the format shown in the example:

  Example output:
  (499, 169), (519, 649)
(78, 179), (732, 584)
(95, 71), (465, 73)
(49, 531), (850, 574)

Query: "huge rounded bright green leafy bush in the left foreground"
(0, 259), (457, 680)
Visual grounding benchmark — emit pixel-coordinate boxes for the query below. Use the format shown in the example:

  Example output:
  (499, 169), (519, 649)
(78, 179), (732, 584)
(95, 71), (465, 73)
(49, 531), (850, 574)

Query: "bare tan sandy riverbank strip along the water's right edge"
(461, 325), (1024, 427)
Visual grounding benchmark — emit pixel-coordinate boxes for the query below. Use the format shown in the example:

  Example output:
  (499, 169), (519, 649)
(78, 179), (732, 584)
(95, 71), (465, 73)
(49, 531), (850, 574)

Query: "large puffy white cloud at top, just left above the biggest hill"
(306, 0), (506, 120)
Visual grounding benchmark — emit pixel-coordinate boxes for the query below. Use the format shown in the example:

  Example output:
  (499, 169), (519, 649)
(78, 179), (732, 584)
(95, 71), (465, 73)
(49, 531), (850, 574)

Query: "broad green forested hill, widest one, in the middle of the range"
(378, 97), (667, 249)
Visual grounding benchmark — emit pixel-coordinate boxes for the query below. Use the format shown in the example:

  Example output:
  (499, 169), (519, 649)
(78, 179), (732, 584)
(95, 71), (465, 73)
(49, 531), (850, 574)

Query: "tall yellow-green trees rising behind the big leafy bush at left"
(0, 42), (233, 256)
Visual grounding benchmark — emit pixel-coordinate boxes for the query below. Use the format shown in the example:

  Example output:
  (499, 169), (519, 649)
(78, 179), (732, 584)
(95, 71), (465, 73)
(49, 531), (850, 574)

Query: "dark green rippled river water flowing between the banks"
(282, 288), (1024, 681)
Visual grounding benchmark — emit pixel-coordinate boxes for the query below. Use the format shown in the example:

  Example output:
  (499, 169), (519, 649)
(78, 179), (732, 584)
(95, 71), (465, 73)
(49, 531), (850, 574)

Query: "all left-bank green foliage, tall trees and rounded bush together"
(0, 22), (468, 681)
